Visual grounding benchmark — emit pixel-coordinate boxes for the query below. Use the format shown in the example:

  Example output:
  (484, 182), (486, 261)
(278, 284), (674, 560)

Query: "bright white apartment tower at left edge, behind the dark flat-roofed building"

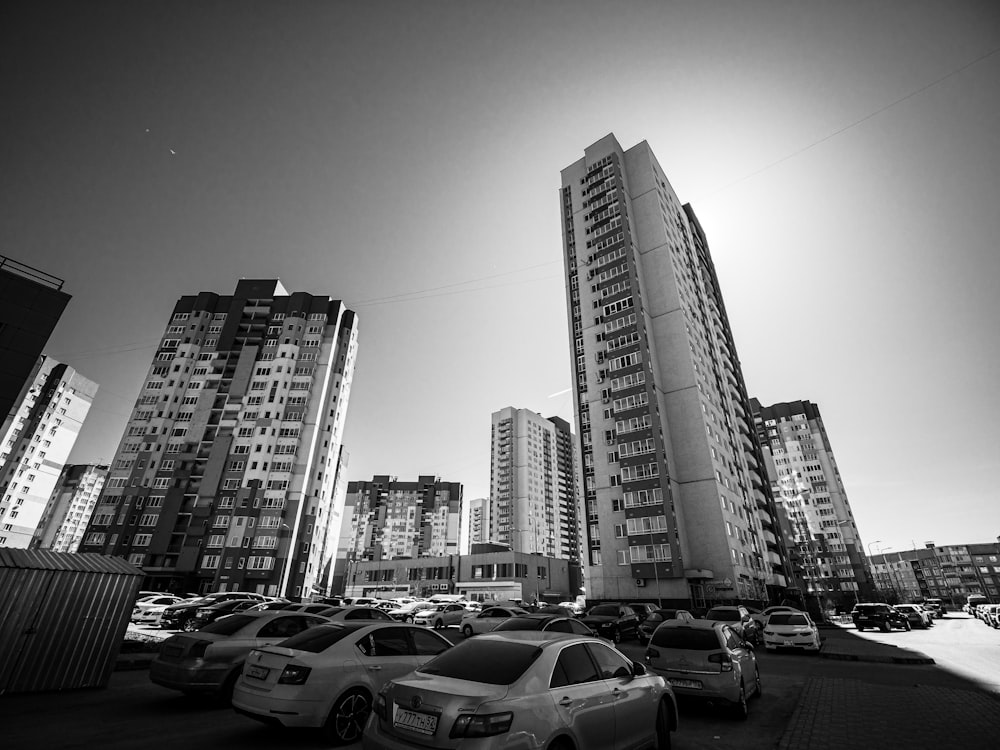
(0, 355), (97, 547)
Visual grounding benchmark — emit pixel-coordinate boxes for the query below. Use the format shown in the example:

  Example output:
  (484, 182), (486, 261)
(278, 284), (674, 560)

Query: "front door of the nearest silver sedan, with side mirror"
(587, 642), (656, 750)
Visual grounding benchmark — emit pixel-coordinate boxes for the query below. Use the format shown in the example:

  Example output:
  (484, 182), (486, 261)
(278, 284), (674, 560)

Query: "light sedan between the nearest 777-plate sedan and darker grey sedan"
(233, 620), (451, 745)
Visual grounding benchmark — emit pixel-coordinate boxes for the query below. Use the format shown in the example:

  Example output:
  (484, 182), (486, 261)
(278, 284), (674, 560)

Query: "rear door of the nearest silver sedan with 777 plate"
(549, 643), (615, 750)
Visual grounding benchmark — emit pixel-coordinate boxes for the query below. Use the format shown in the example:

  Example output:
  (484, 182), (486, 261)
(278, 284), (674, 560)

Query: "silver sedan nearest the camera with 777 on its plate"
(364, 632), (677, 750)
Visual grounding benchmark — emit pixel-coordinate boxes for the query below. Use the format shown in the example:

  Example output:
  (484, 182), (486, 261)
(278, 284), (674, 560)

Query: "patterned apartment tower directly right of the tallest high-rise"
(750, 398), (874, 606)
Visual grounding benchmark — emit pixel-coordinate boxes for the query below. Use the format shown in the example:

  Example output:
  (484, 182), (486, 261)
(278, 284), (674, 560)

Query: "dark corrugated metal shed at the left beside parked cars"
(0, 548), (142, 694)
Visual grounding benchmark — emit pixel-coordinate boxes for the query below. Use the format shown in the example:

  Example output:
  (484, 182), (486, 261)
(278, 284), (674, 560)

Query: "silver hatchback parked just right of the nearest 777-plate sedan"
(646, 620), (762, 719)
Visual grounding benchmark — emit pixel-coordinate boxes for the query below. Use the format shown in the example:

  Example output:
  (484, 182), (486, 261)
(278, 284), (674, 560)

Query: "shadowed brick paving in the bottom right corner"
(778, 677), (1000, 750)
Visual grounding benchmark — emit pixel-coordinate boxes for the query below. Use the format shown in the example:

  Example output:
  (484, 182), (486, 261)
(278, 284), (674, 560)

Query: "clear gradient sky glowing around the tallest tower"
(0, 0), (1000, 560)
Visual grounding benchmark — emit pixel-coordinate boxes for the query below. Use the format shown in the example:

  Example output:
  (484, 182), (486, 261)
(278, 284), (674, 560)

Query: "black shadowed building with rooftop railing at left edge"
(0, 255), (70, 434)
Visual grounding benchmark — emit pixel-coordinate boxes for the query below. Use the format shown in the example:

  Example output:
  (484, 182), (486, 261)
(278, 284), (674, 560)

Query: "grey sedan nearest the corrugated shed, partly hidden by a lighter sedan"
(149, 611), (328, 696)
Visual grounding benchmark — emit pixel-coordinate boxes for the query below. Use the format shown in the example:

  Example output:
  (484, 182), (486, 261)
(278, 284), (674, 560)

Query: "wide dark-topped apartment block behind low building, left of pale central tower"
(340, 475), (462, 566)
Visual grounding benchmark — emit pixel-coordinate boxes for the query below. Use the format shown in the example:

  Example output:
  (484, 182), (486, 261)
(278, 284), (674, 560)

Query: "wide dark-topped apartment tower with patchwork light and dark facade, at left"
(80, 279), (358, 598)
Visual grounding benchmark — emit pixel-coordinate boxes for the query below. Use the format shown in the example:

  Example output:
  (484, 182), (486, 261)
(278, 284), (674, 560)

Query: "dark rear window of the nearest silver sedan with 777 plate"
(417, 640), (542, 685)
